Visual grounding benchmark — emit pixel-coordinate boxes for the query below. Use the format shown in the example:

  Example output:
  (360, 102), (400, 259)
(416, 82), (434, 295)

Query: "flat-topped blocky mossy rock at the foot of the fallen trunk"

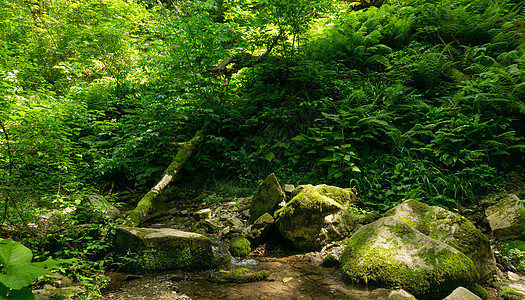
(113, 226), (214, 273)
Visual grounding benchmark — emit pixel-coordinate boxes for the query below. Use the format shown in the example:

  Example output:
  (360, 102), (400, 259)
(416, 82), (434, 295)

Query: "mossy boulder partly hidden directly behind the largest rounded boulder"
(385, 200), (497, 282)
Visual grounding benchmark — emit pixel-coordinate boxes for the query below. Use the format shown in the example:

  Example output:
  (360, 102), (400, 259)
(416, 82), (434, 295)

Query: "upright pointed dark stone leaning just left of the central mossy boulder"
(249, 173), (286, 223)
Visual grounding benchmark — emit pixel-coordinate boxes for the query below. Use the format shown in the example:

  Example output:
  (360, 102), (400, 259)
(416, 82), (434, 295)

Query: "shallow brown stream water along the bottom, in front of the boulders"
(105, 254), (389, 300)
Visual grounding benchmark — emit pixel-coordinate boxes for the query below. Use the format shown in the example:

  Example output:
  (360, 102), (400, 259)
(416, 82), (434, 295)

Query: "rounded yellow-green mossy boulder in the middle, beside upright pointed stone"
(274, 185), (355, 251)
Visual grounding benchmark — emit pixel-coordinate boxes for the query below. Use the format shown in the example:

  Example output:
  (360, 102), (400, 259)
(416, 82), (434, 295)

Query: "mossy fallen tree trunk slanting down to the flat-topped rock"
(125, 129), (204, 227)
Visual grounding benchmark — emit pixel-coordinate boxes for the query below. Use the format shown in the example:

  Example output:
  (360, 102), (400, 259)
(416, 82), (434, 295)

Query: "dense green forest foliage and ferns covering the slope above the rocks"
(0, 0), (525, 299)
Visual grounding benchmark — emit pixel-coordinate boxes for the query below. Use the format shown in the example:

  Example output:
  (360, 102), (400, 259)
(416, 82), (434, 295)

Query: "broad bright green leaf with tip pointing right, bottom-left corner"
(0, 265), (51, 290)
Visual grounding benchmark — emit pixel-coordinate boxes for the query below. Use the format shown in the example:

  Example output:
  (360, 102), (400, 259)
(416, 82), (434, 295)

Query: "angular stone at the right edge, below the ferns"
(485, 194), (525, 241)
